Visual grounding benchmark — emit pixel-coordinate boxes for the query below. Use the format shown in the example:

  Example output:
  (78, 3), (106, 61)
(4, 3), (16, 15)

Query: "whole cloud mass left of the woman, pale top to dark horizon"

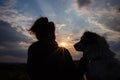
(0, 0), (33, 58)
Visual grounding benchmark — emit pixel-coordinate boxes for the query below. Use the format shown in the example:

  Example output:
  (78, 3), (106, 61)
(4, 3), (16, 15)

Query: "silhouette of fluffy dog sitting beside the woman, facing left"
(74, 31), (120, 80)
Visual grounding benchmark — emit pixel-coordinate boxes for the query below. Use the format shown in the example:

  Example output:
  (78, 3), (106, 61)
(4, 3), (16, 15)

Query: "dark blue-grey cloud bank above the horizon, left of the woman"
(0, 20), (28, 57)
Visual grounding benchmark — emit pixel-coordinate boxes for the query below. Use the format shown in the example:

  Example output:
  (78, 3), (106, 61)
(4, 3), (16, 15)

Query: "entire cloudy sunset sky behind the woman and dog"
(0, 0), (120, 62)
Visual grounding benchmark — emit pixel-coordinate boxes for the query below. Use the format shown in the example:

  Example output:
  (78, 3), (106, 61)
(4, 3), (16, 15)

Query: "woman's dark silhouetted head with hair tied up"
(30, 17), (55, 40)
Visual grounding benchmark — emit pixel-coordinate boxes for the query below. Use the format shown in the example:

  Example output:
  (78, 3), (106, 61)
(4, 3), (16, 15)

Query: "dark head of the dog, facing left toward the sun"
(74, 31), (109, 60)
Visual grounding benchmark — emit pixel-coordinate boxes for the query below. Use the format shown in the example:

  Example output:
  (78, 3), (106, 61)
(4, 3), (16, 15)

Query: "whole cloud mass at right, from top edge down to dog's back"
(73, 0), (120, 58)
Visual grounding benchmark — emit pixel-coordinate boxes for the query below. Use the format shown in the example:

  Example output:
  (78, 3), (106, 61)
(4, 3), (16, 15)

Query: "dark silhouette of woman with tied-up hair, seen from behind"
(27, 17), (75, 80)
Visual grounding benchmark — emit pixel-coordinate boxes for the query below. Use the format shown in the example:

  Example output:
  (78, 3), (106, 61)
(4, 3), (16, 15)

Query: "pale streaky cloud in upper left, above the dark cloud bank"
(0, 0), (33, 38)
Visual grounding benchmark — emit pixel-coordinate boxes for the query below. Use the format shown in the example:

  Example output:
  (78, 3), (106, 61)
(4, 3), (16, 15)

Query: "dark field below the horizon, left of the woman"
(0, 61), (78, 80)
